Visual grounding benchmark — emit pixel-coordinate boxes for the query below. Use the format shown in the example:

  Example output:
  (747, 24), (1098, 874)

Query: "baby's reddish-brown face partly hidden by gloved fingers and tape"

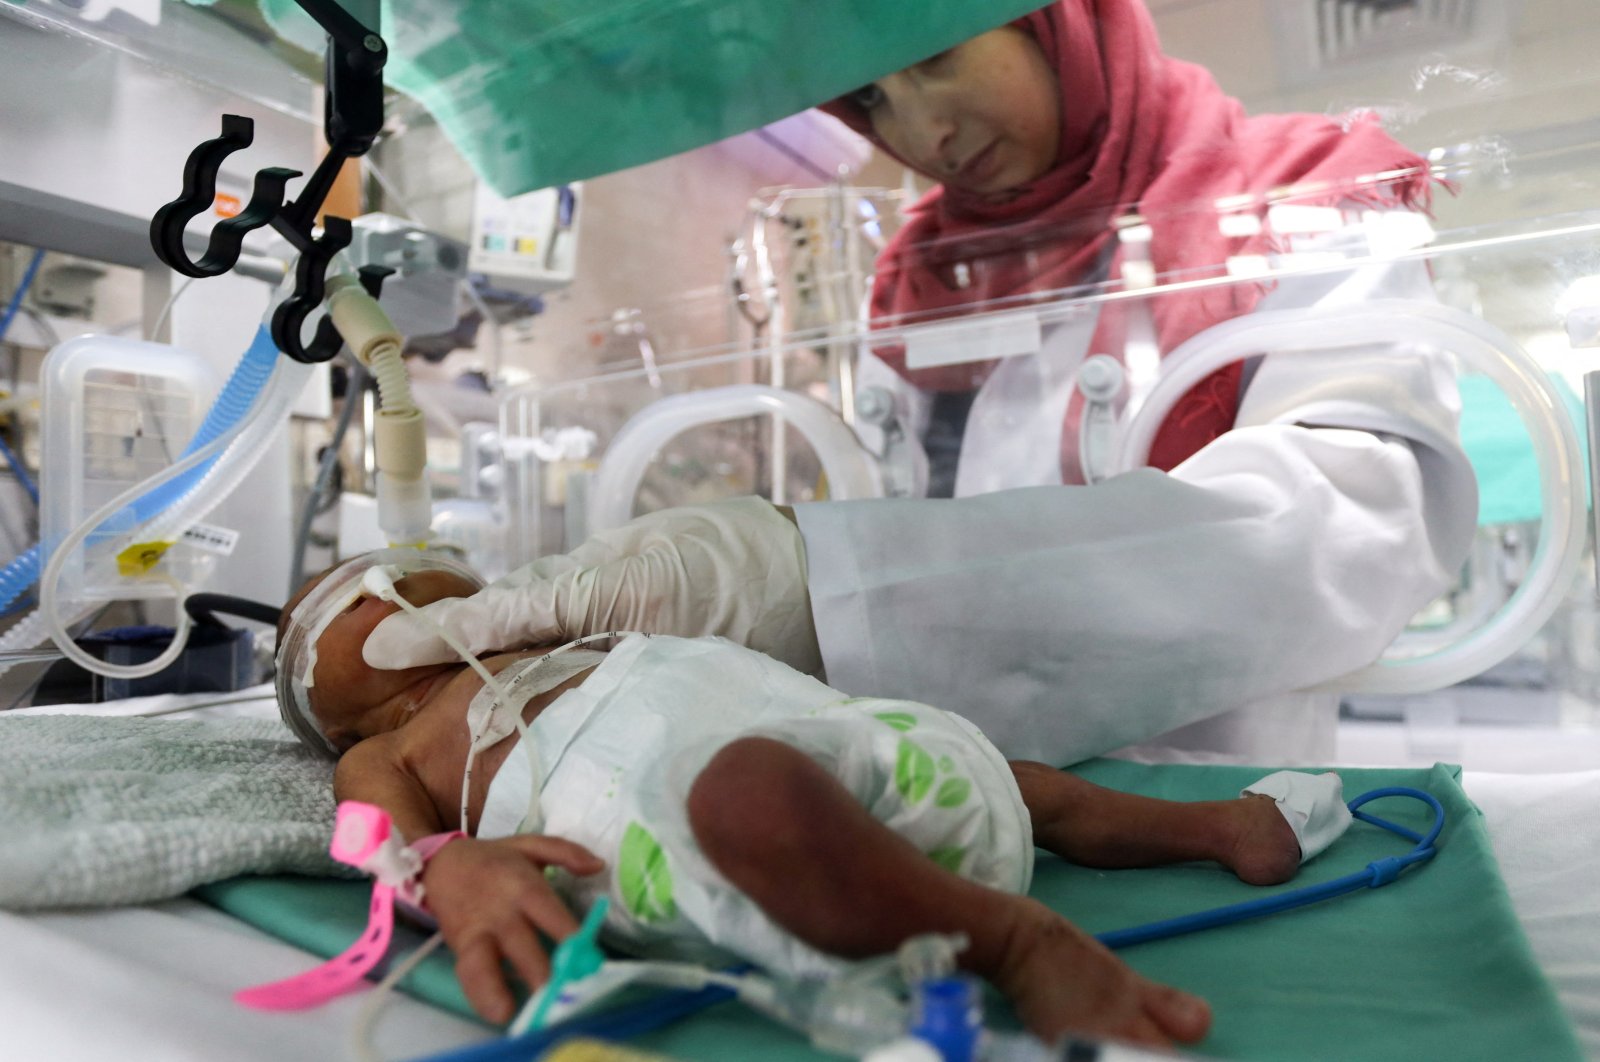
(300, 571), (477, 752)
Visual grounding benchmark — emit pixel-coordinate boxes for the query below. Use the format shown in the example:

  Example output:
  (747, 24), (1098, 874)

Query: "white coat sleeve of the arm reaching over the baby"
(795, 425), (1448, 763)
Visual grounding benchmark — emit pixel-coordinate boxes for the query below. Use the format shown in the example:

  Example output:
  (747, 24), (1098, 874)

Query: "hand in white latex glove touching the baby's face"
(362, 497), (822, 673)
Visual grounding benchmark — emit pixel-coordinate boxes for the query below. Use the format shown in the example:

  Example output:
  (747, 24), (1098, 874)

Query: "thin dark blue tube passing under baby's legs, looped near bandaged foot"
(406, 785), (1445, 1062)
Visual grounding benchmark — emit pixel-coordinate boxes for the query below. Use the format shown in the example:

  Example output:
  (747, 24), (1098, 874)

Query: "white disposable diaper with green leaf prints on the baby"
(478, 637), (1034, 976)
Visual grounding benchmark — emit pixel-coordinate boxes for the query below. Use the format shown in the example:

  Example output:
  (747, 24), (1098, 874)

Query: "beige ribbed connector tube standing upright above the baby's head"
(328, 275), (434, 545)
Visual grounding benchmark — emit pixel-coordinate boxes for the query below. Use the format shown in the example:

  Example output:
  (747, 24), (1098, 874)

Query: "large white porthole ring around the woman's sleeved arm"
(1114, 299), (1587, 694)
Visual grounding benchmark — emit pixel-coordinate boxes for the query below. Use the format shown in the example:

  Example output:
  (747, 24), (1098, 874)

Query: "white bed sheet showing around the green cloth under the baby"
(0, 688), (1600, 1062)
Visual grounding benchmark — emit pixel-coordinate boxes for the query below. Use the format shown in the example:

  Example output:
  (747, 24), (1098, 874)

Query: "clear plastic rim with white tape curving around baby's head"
(274, 549), (483, 758)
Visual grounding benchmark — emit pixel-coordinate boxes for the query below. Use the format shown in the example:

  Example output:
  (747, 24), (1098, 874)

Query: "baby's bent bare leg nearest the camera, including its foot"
(688, 737), (1211, 1044)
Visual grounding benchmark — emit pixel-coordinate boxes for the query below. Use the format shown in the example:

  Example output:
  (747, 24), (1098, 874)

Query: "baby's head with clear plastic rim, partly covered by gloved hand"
(277, 549), (483, 758)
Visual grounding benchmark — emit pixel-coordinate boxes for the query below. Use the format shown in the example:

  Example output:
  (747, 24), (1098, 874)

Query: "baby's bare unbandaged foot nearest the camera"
(992, 900), (1211, 1048)
